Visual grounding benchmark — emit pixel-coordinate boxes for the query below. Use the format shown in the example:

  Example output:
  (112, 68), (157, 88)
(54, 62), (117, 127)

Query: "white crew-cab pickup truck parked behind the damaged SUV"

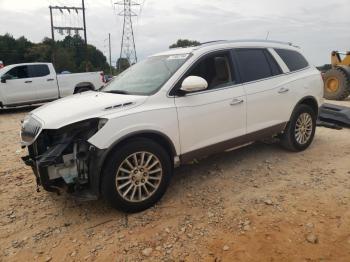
(0, 63), (104, 108)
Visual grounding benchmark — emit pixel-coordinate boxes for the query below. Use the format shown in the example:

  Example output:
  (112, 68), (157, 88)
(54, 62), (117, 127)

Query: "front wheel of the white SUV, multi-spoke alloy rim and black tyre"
(101, 138), (173, 213)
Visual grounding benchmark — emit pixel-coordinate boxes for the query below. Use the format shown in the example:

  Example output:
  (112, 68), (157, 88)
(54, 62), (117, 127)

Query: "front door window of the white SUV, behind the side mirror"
(186, 52), (234, 89)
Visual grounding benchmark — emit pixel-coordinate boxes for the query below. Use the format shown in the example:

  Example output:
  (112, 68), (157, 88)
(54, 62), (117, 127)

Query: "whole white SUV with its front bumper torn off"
(21, 41), (323, 212)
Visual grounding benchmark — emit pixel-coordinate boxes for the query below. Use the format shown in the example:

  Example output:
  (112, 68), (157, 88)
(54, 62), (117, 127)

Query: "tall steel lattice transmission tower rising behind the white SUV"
(115, 0), (140, 69)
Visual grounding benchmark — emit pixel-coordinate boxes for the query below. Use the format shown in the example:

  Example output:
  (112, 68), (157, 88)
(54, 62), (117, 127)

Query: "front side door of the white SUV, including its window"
(175, 51), (246, 159)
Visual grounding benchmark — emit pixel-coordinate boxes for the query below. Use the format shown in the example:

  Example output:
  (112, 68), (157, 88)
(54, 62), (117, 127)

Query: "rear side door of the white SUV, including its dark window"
(233, 48), (295, 133)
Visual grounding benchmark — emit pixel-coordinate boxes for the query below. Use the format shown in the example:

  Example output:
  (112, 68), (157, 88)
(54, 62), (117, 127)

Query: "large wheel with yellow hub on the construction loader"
(323, 68), (350, 100)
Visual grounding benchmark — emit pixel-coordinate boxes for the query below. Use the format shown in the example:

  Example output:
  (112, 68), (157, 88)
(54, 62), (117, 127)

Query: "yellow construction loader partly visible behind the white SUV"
(323, 51), (350, 100)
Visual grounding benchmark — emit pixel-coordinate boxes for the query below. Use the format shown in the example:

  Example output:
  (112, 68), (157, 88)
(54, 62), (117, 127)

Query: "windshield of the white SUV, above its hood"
(101, 54), (189, 95)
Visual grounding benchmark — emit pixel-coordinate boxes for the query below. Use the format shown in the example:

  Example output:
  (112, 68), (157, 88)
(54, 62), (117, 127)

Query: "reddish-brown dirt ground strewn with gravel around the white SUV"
(0, 101), (350, 261)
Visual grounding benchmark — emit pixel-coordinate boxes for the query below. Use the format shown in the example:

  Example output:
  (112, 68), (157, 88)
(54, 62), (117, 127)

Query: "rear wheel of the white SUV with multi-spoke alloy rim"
(281, 104), (316, 152)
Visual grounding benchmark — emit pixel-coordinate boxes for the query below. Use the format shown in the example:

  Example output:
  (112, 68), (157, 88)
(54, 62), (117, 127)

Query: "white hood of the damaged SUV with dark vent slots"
(31, 91), (147, 129)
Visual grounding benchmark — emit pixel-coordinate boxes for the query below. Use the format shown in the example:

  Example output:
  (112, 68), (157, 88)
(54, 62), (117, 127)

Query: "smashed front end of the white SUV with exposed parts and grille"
(21, 116), (107, 199)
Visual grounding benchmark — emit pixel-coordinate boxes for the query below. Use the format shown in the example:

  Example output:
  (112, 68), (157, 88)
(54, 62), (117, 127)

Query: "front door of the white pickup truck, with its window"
(1, 65), (37, 105)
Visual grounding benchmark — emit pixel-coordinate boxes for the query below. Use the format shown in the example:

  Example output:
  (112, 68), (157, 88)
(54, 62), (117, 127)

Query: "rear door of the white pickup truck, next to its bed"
(28, 64), (58, 101)
